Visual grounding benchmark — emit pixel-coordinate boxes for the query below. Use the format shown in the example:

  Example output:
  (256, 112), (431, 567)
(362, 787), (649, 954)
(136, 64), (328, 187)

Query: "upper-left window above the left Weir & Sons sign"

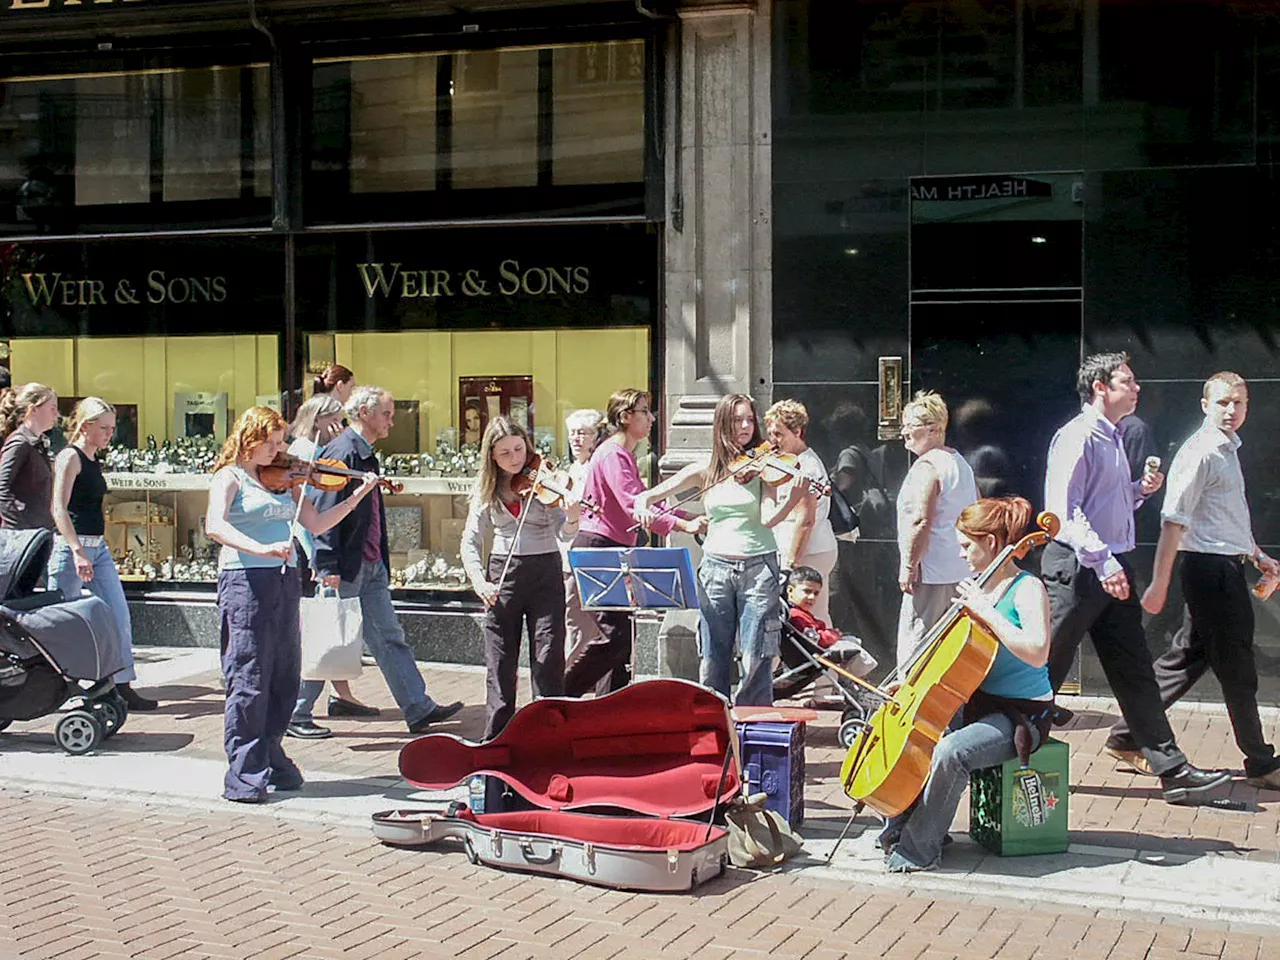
(0, 64), (271, 234)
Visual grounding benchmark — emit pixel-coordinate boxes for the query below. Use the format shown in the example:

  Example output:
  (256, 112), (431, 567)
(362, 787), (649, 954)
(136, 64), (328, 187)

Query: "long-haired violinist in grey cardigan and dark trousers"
(462, 417), (580, 740)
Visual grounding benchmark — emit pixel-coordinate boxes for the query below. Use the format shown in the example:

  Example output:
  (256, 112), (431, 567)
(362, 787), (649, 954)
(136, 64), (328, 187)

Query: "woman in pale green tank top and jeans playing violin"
(632, 393), (808, 705)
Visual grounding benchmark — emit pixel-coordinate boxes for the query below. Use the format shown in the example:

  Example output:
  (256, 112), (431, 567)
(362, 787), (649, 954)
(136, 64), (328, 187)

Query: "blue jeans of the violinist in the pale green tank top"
(698, 553), (782, 707)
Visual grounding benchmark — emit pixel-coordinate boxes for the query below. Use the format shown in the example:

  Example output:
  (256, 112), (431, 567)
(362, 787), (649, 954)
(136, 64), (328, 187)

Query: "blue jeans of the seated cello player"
(881, 713), (1039, 868)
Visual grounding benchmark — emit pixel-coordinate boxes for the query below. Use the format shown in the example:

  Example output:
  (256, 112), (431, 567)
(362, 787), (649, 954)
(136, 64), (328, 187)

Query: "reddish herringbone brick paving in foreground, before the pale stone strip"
(0, 788), (1280, 960)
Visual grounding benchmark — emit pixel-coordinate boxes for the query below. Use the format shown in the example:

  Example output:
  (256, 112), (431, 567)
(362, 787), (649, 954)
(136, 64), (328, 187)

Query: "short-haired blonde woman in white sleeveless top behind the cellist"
(897, 390), (978, 667)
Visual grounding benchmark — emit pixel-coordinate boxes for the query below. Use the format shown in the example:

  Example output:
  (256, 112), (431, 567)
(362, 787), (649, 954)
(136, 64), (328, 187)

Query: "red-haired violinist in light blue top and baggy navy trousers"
(205, 407), (378, 804)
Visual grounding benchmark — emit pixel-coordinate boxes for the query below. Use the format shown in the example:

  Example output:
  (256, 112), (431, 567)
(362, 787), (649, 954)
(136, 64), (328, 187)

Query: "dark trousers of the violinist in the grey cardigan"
(484, 552), (564, 740)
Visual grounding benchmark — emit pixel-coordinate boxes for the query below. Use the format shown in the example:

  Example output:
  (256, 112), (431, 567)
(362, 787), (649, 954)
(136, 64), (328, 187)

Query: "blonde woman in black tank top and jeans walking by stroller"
(49, 397), (156, 710)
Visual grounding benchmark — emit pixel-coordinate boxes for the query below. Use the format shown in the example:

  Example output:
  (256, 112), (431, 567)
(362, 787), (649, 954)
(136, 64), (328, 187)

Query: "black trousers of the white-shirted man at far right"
(1111, 553), (1280, 777)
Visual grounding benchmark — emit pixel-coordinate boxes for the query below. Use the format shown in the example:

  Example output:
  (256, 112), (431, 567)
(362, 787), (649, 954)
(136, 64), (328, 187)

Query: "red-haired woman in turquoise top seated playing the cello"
(879, 497), (1053, 873)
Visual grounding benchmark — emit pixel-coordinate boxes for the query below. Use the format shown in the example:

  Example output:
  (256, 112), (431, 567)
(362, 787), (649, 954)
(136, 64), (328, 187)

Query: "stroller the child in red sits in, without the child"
(773, 596), (881, 749)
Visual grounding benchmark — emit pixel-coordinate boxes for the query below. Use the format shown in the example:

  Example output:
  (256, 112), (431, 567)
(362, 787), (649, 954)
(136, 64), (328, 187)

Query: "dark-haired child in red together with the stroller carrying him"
(773, 567), (879, 746)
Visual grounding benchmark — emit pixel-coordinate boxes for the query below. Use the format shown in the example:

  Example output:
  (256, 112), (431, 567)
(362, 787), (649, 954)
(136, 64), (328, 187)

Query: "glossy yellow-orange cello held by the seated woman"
(840, 512), (1059, 817)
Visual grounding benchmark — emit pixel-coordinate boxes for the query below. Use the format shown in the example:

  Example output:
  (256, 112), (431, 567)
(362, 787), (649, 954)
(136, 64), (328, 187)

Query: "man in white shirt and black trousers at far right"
(1107, 371), (1280, 790)
